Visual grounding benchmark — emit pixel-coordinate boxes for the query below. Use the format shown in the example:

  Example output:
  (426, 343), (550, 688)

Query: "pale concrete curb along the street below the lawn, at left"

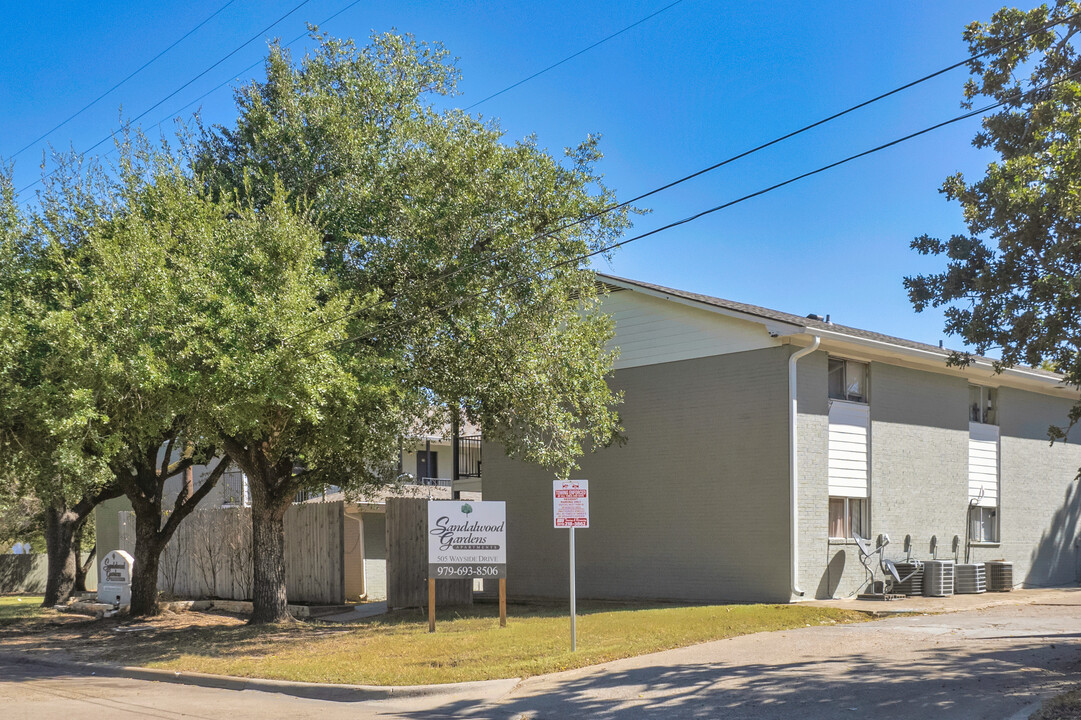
(0, 653), (521, 703)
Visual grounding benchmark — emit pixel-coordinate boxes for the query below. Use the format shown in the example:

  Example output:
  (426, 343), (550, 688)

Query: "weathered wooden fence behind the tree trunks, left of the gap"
(120, 502), (345, 603)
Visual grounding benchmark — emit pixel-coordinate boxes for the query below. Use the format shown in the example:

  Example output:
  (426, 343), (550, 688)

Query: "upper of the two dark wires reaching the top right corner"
(281, 13), (1081, 343)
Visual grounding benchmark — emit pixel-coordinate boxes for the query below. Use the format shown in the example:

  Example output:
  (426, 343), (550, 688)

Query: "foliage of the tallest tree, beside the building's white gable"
(197, 34), (628, 479)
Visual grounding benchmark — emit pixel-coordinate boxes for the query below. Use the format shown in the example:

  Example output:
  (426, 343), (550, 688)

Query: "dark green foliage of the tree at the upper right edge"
(905, 0), (1081, 437)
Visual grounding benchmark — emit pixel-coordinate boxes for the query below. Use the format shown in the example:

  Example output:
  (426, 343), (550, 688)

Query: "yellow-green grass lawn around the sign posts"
(132, 605), (866, 685)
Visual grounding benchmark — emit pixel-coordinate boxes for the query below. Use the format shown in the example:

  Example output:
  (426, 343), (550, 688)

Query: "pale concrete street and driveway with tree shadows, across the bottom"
(0, 591), (1081, 720)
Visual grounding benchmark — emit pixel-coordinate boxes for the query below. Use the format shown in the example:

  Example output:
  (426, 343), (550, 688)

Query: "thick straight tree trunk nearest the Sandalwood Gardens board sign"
(251, 492), (293, 625)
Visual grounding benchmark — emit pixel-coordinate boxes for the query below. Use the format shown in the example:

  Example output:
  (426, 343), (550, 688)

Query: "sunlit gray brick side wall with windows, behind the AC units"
(799, 352), (1081, 598)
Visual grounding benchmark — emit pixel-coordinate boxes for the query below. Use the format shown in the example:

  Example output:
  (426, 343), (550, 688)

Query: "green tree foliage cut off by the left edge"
(0, 158), (117, 504)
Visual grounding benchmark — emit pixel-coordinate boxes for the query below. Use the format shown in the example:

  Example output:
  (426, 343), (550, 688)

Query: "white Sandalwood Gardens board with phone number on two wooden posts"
(428, 501), (507, 578)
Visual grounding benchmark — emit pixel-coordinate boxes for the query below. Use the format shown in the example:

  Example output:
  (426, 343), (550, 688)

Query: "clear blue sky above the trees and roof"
(0, 0), (1001, 347)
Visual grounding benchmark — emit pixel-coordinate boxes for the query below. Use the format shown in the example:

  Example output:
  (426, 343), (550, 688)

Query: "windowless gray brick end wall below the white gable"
(484, 347), (791, 602)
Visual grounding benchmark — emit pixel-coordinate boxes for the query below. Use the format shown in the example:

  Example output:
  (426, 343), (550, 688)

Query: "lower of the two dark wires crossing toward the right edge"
(303, 70), (1081, 358)
